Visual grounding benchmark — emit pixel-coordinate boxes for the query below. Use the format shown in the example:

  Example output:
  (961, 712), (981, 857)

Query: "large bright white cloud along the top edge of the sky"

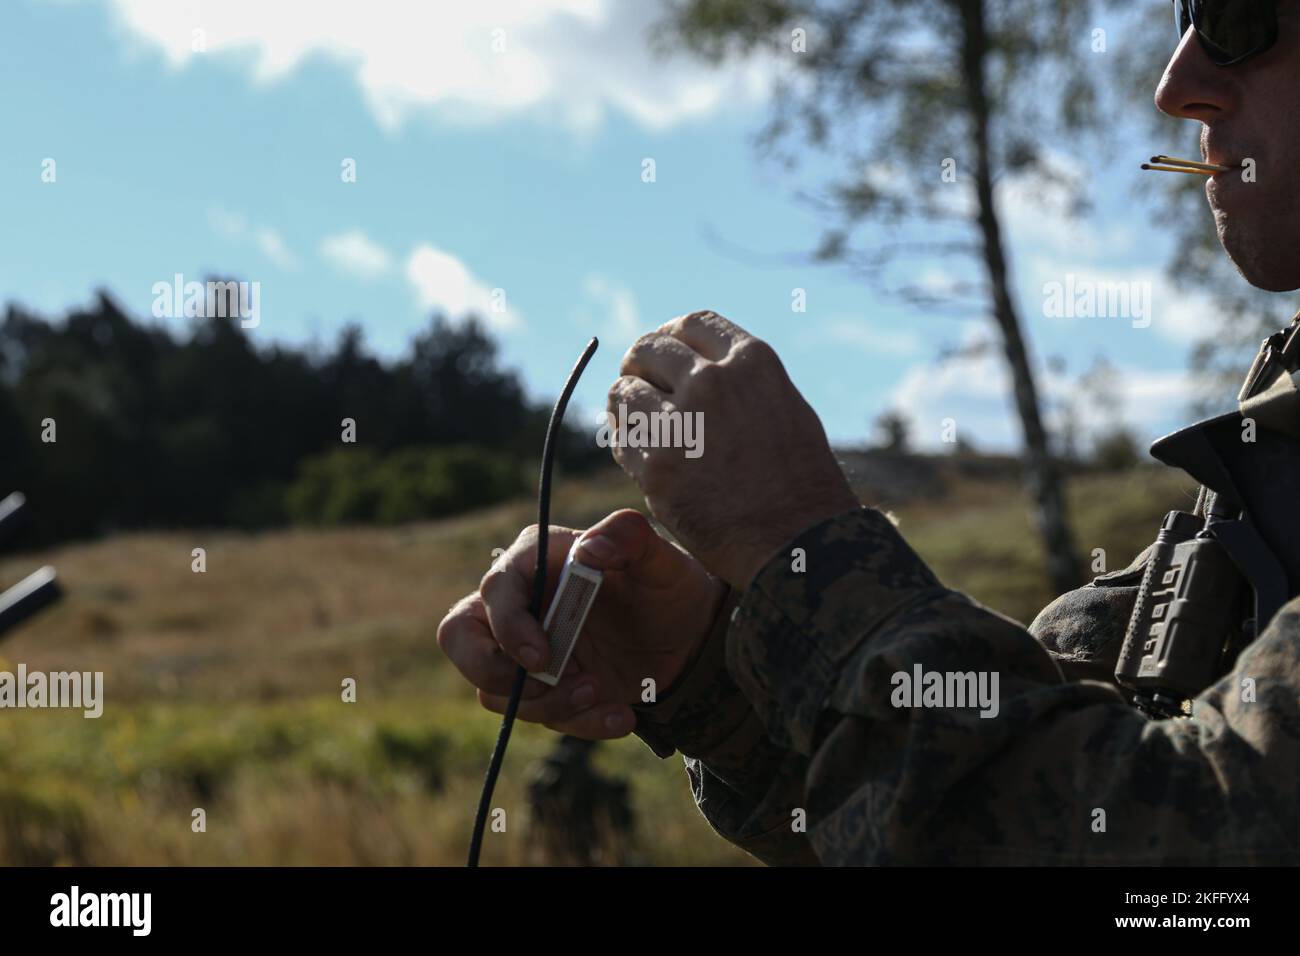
(107, 0), (772, 129)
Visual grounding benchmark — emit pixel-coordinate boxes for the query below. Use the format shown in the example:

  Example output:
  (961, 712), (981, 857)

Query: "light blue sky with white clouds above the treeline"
(0, 0), (1242, 447)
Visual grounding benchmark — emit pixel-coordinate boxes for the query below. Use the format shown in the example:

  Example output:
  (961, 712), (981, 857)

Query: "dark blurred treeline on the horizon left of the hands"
(0, 293), (605, 545)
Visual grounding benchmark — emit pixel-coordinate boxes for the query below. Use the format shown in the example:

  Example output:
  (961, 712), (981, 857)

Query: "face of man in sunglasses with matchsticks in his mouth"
(1156, 0), (1300, 291)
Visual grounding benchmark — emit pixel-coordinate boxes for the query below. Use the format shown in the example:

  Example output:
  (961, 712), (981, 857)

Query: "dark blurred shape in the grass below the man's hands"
(528, 736), (636, 866)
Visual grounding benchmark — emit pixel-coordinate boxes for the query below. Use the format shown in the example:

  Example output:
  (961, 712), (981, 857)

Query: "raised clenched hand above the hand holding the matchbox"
(608, 312), (858, 589)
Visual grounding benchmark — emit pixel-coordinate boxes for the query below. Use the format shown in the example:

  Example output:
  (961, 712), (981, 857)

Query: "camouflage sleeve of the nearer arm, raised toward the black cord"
(727, 509), (1300, 865)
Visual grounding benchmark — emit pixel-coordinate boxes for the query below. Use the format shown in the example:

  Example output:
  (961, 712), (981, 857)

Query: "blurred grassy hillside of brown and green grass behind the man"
(0, 468), (1195, 865)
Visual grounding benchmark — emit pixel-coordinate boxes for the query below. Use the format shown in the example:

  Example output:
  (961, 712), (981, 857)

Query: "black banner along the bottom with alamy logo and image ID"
(0, 868), (1274, 952)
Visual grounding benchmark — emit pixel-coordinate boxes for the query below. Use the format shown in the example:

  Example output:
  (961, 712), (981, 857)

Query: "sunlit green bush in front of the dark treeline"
(285, 445), (527, 525)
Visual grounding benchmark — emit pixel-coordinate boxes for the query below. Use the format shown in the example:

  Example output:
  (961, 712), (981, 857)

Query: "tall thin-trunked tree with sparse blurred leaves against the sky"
(657, 0), (1123, 591)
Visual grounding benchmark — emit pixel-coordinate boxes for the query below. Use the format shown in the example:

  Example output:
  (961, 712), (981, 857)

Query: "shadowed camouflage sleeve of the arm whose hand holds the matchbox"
(633, 592), (818, 865)
